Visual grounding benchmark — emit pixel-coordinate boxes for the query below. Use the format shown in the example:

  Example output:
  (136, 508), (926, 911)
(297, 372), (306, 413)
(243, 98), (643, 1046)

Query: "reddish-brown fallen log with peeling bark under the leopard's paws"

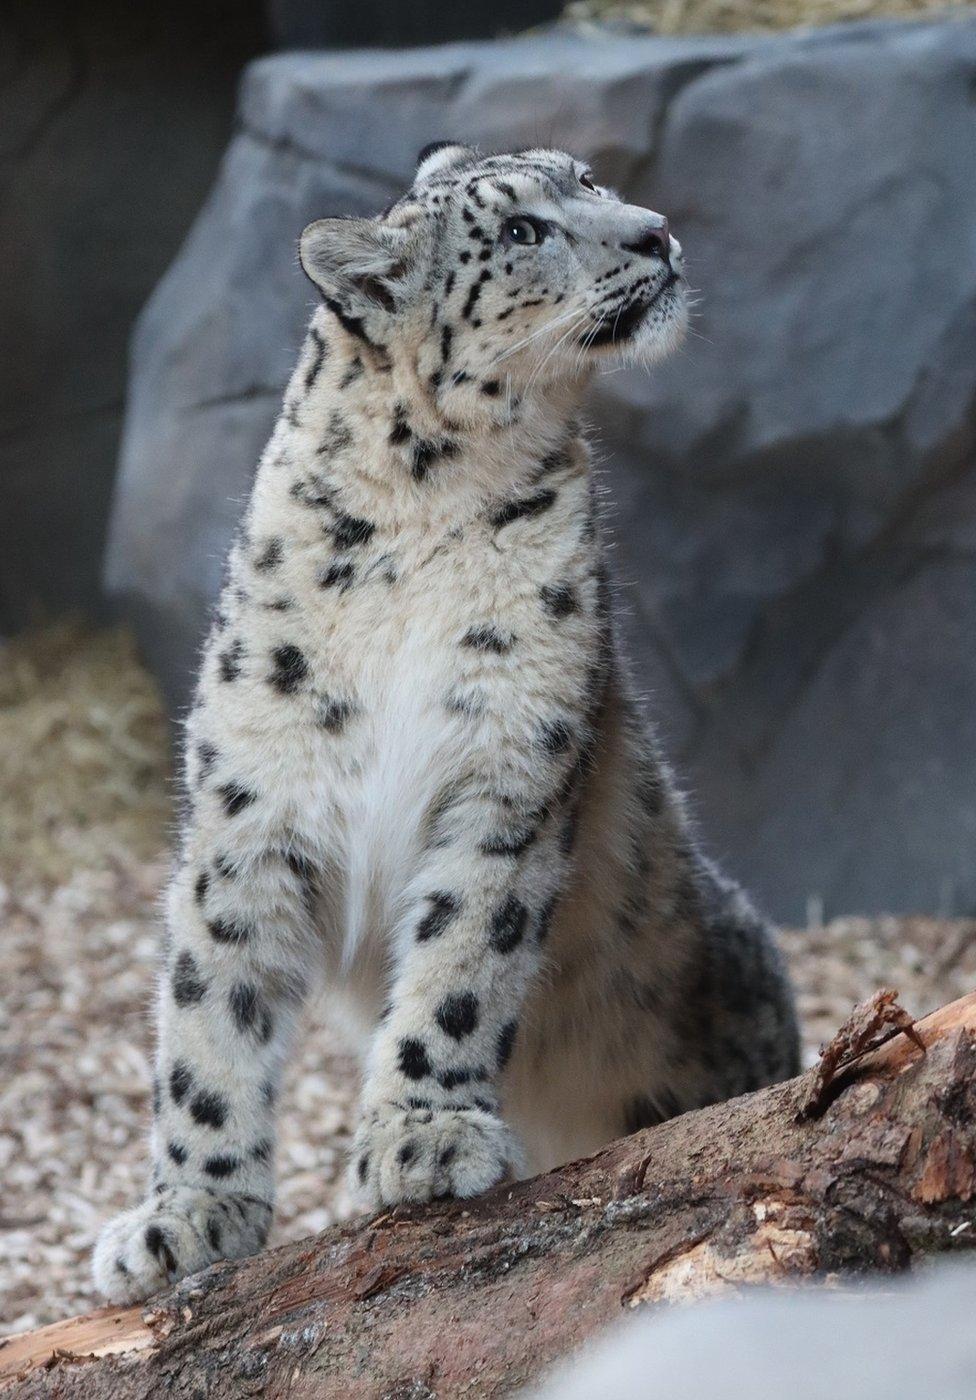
(0, 993), (976, 1400)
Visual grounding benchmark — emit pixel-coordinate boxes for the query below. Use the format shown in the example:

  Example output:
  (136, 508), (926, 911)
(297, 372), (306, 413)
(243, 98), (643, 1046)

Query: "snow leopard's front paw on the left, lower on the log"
(92, 1186), (272, 1303)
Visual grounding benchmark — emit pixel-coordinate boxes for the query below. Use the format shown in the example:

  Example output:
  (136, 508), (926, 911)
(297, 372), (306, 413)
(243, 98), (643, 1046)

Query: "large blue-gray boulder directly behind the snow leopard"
(106, 19), (976, 920)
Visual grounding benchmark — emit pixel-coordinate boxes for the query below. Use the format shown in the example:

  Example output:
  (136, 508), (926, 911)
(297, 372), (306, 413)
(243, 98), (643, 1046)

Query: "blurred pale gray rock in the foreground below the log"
(524, 1264), (976, 1400)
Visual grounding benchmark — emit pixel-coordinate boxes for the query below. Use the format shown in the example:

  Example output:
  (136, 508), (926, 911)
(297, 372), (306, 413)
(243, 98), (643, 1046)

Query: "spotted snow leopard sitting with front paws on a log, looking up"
(94, 143), (798, 1302)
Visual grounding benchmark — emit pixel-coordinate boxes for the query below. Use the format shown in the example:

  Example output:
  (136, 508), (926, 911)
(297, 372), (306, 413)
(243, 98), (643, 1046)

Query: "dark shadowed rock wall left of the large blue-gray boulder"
(0, 0), (265, 631)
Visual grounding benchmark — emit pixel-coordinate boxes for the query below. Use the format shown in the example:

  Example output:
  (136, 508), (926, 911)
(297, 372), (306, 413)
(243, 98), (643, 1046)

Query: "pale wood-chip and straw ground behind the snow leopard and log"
(0, 631), (976, 1333)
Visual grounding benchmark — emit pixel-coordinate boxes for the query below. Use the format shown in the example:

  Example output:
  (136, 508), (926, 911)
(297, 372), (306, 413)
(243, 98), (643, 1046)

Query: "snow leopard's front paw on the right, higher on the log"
(349, 1103), (520, 1210)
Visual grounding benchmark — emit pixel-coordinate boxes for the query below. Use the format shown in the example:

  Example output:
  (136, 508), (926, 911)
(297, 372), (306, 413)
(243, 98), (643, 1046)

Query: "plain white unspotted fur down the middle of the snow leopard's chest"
(292, 526), (515, 962)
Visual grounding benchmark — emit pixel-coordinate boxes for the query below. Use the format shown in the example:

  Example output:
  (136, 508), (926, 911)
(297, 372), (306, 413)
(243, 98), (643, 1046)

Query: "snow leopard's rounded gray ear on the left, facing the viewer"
(298, 218), (409, 309)
